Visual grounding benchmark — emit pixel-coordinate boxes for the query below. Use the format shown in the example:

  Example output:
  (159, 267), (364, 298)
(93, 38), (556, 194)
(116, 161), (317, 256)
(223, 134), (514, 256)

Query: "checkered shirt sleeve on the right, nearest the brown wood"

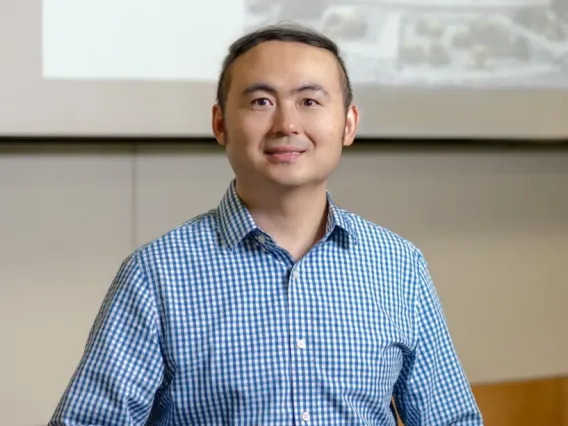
(394, 252), (483, 426)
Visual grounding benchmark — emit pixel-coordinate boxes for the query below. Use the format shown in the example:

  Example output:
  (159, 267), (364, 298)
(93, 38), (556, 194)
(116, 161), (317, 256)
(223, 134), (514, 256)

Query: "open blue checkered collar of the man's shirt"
(217, 179), (357, 249)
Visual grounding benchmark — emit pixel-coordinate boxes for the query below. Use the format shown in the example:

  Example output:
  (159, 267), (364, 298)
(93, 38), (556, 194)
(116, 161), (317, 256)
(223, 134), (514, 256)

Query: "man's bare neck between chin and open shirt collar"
(237, 181), (328, 261)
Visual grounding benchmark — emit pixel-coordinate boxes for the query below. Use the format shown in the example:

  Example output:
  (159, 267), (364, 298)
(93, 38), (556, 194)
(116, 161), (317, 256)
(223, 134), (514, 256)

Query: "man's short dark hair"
(217, 23), (353, 110)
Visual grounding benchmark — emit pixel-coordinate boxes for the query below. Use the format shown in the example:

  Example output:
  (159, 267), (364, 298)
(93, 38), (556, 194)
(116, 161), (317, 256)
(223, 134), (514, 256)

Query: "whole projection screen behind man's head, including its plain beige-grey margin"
(0, 0), (568, 140)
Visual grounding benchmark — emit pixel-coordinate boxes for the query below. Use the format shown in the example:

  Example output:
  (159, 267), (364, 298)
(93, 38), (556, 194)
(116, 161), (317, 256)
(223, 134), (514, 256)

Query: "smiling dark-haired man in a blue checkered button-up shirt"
(50, 25), (482, 426)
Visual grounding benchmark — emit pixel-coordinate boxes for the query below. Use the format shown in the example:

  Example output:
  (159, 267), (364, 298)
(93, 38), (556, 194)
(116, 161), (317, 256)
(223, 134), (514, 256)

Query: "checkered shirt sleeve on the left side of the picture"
(49, 256), (164, 426)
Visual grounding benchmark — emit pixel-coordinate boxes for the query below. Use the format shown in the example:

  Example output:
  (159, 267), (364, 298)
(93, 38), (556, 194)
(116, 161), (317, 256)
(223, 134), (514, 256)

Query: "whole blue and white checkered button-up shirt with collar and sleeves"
(49, 181), (483, 426)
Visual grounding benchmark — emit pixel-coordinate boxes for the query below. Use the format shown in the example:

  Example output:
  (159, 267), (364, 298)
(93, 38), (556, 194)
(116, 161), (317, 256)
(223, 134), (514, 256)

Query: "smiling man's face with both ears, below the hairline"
(213, 41), (359, 188)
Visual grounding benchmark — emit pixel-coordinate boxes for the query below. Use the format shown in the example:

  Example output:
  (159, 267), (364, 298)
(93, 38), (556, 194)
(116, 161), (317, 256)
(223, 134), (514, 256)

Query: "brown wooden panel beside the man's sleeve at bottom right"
(399, 377), (568, 426)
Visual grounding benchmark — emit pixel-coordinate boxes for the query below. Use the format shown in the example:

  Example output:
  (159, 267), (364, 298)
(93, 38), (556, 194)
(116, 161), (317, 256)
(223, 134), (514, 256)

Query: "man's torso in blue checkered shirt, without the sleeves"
(139, 188), (415, 425)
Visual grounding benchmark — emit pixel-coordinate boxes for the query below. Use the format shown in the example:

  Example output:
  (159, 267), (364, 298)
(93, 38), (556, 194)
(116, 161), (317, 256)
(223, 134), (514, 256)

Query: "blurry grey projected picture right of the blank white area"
(245, 0), (568, 86)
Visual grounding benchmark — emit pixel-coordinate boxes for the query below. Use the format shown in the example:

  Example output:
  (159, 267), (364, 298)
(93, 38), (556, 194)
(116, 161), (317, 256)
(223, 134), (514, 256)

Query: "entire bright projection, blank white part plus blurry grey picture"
(43, 0), (568, 88)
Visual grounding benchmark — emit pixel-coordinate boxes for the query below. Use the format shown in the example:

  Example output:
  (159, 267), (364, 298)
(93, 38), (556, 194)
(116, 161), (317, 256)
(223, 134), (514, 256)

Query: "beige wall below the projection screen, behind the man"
(0, 146), (568, 426)
